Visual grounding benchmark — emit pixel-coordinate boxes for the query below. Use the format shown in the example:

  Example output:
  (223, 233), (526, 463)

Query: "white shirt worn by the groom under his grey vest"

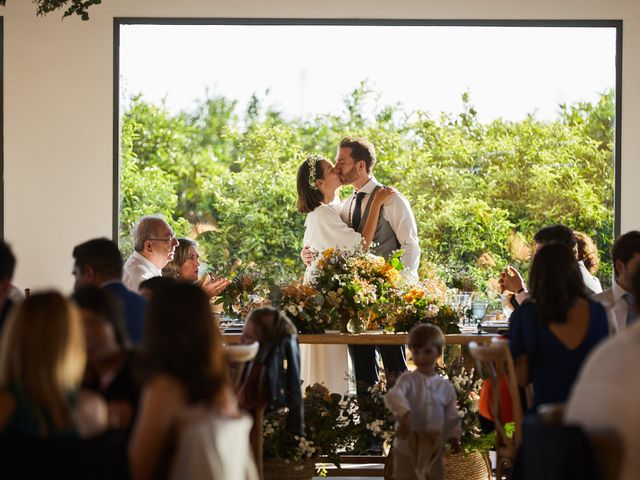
(340, 176), (420, 281)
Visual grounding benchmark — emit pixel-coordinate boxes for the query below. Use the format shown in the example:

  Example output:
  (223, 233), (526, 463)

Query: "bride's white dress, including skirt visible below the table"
(300, 203), (362, 394)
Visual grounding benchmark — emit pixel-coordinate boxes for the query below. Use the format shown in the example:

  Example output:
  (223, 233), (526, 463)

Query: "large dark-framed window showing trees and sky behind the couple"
(115, 20), (621, 289)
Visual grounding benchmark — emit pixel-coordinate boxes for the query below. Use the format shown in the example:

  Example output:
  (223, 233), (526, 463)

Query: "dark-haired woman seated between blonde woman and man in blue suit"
(73, 287), (141, 429)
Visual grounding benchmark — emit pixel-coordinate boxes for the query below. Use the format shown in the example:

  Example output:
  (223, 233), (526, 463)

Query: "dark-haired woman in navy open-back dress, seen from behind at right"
(509, 243), (608, 407)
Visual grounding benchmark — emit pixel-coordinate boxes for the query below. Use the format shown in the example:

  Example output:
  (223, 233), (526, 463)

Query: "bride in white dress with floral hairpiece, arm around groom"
(297, 156), (395, 394)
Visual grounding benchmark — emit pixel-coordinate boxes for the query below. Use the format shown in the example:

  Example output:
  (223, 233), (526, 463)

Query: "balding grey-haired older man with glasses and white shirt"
(122, 215), (178, 293)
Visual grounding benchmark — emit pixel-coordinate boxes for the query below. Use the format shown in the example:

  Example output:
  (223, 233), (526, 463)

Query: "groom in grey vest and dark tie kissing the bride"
(302, 137), (420, 397)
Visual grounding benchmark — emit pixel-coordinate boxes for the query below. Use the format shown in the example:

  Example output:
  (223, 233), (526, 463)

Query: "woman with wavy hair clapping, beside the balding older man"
(162, 238), (230, 298)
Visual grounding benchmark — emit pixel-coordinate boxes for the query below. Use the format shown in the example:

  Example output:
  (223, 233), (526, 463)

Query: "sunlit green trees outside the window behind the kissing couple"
(120, 82), (615, 288)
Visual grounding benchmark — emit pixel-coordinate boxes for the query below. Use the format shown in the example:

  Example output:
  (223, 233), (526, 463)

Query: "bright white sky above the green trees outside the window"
(120, 25), (615, 121)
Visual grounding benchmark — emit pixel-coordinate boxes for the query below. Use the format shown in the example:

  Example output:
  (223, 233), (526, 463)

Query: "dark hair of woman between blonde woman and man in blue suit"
(72, 287), (130, 348)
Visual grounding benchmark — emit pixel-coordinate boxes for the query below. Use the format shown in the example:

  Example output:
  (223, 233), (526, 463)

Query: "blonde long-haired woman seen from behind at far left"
(0, 292), (107, 437)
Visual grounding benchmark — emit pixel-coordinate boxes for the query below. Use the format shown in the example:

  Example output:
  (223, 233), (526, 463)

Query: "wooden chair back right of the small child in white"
(469, 338), (523, 479)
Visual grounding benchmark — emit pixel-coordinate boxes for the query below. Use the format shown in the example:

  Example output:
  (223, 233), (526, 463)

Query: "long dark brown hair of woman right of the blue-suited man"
(143, 281), (227, 403)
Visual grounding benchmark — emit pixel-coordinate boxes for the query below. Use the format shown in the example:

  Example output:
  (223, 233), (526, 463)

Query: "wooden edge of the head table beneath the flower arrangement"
(223, 330), (500, 345)
